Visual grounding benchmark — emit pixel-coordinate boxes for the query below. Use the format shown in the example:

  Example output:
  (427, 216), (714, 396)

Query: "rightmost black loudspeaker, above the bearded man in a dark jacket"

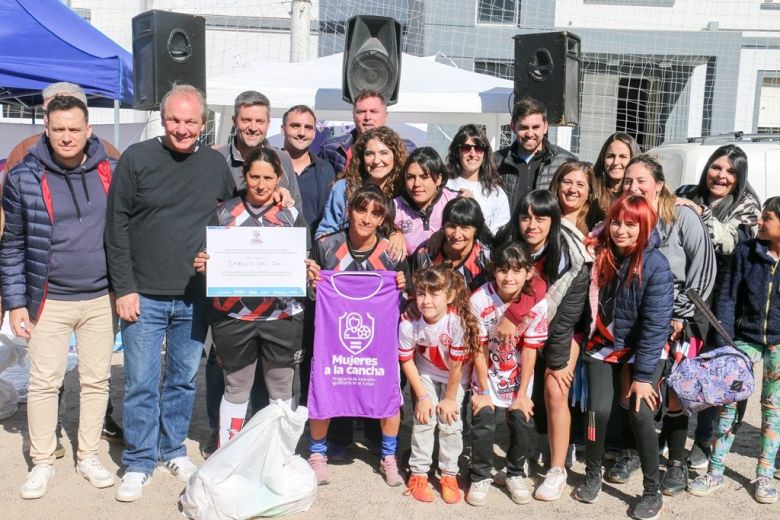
(514, 31), (581, 126)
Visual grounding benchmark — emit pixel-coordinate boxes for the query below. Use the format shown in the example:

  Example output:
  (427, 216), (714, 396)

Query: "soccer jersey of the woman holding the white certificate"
(212, 197), (306, 321)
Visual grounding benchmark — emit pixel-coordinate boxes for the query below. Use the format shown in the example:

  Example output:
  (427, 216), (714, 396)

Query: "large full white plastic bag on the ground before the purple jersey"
(181, 401), (317, 520)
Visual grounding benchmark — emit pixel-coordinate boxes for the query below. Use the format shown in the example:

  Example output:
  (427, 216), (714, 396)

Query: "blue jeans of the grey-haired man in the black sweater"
(121, 294), (208, 474)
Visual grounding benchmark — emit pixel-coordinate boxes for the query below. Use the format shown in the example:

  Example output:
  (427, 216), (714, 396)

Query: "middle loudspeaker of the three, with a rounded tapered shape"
(341, 16), (401, 105)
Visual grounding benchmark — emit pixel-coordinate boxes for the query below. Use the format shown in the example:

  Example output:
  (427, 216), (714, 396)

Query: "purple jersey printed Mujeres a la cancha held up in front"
(308, 270), (403, 419)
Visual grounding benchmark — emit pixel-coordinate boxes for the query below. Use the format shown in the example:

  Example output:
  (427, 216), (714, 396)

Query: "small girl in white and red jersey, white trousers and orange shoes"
(406, 263), (479, 504)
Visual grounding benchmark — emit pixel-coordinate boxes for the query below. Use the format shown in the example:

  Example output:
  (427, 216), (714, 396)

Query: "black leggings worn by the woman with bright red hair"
(585, 356), (664, 493)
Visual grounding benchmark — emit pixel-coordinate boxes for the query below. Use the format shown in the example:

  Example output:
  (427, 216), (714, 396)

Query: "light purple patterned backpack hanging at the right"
(666, 345), (755, 415)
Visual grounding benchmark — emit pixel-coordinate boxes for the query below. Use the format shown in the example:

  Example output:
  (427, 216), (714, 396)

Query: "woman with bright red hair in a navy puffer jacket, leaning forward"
(574, 195), (674, 519)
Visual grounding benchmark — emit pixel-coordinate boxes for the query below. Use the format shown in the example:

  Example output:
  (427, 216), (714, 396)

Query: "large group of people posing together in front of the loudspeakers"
(0, 80), (780, 519)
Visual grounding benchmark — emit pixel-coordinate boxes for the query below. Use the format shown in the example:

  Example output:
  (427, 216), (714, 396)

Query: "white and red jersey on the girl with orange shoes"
(398, 308), (471, 385)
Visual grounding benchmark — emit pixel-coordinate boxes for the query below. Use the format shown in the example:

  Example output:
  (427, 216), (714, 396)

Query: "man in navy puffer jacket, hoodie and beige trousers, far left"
(0, 96), (116, 499)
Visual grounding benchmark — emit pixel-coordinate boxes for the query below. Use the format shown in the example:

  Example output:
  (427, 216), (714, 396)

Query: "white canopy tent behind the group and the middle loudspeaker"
(207, 54), (513, 146)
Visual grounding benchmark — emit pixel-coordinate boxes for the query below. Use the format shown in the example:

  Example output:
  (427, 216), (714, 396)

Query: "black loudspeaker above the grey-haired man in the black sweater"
(133, 10), (206, 110)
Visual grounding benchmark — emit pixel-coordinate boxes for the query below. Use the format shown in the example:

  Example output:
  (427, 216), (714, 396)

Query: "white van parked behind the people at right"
(647, 132), (780, 203)
